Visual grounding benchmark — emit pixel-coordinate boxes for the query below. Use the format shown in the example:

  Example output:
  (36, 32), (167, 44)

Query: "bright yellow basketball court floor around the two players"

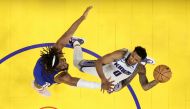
(0, 0), (190, 109)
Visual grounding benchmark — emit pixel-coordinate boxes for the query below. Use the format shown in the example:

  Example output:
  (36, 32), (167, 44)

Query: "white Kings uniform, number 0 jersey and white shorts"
(81, 52), (138, 85)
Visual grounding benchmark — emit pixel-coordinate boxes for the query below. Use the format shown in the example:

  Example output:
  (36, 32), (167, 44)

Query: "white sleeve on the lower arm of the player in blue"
(77, 79), (101, 89)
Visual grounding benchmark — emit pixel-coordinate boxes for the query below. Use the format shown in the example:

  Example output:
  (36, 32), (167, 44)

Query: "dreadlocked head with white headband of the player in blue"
(41, 47), (68, 73)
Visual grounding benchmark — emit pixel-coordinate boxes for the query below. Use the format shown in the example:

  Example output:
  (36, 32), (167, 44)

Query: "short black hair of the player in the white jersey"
(134, 46), (147, 60)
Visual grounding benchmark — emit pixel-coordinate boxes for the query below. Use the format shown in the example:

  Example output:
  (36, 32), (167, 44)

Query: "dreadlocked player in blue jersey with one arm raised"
(33, 6), (104, 96)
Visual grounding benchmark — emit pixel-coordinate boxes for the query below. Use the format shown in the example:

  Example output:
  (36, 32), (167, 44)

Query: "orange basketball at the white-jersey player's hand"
(153, 65), (172, 83)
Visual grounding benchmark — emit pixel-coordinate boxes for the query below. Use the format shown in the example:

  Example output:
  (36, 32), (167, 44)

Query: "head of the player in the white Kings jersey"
(127, 46), (147, 65)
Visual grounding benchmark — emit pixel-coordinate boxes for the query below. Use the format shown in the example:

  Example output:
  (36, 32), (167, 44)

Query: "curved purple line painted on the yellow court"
(0, 43), (141, 109)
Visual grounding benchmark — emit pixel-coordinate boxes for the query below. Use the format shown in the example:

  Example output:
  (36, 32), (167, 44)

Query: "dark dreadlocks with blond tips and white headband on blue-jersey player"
(41, 46), (63, 73)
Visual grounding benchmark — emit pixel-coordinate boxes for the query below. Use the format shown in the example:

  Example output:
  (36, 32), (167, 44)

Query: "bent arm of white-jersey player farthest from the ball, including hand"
(96, 49), (127, 91)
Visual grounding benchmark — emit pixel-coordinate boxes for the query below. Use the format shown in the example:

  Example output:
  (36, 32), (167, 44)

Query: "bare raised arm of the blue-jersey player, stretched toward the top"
(55, 6), (92, 50)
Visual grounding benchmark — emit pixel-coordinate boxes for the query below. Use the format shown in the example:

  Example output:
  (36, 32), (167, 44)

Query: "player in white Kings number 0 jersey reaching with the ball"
(73, 41), (159, 93)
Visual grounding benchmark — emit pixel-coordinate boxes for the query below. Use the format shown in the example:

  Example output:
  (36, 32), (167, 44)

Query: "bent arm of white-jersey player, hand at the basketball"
(138, 65), (159, 91)
